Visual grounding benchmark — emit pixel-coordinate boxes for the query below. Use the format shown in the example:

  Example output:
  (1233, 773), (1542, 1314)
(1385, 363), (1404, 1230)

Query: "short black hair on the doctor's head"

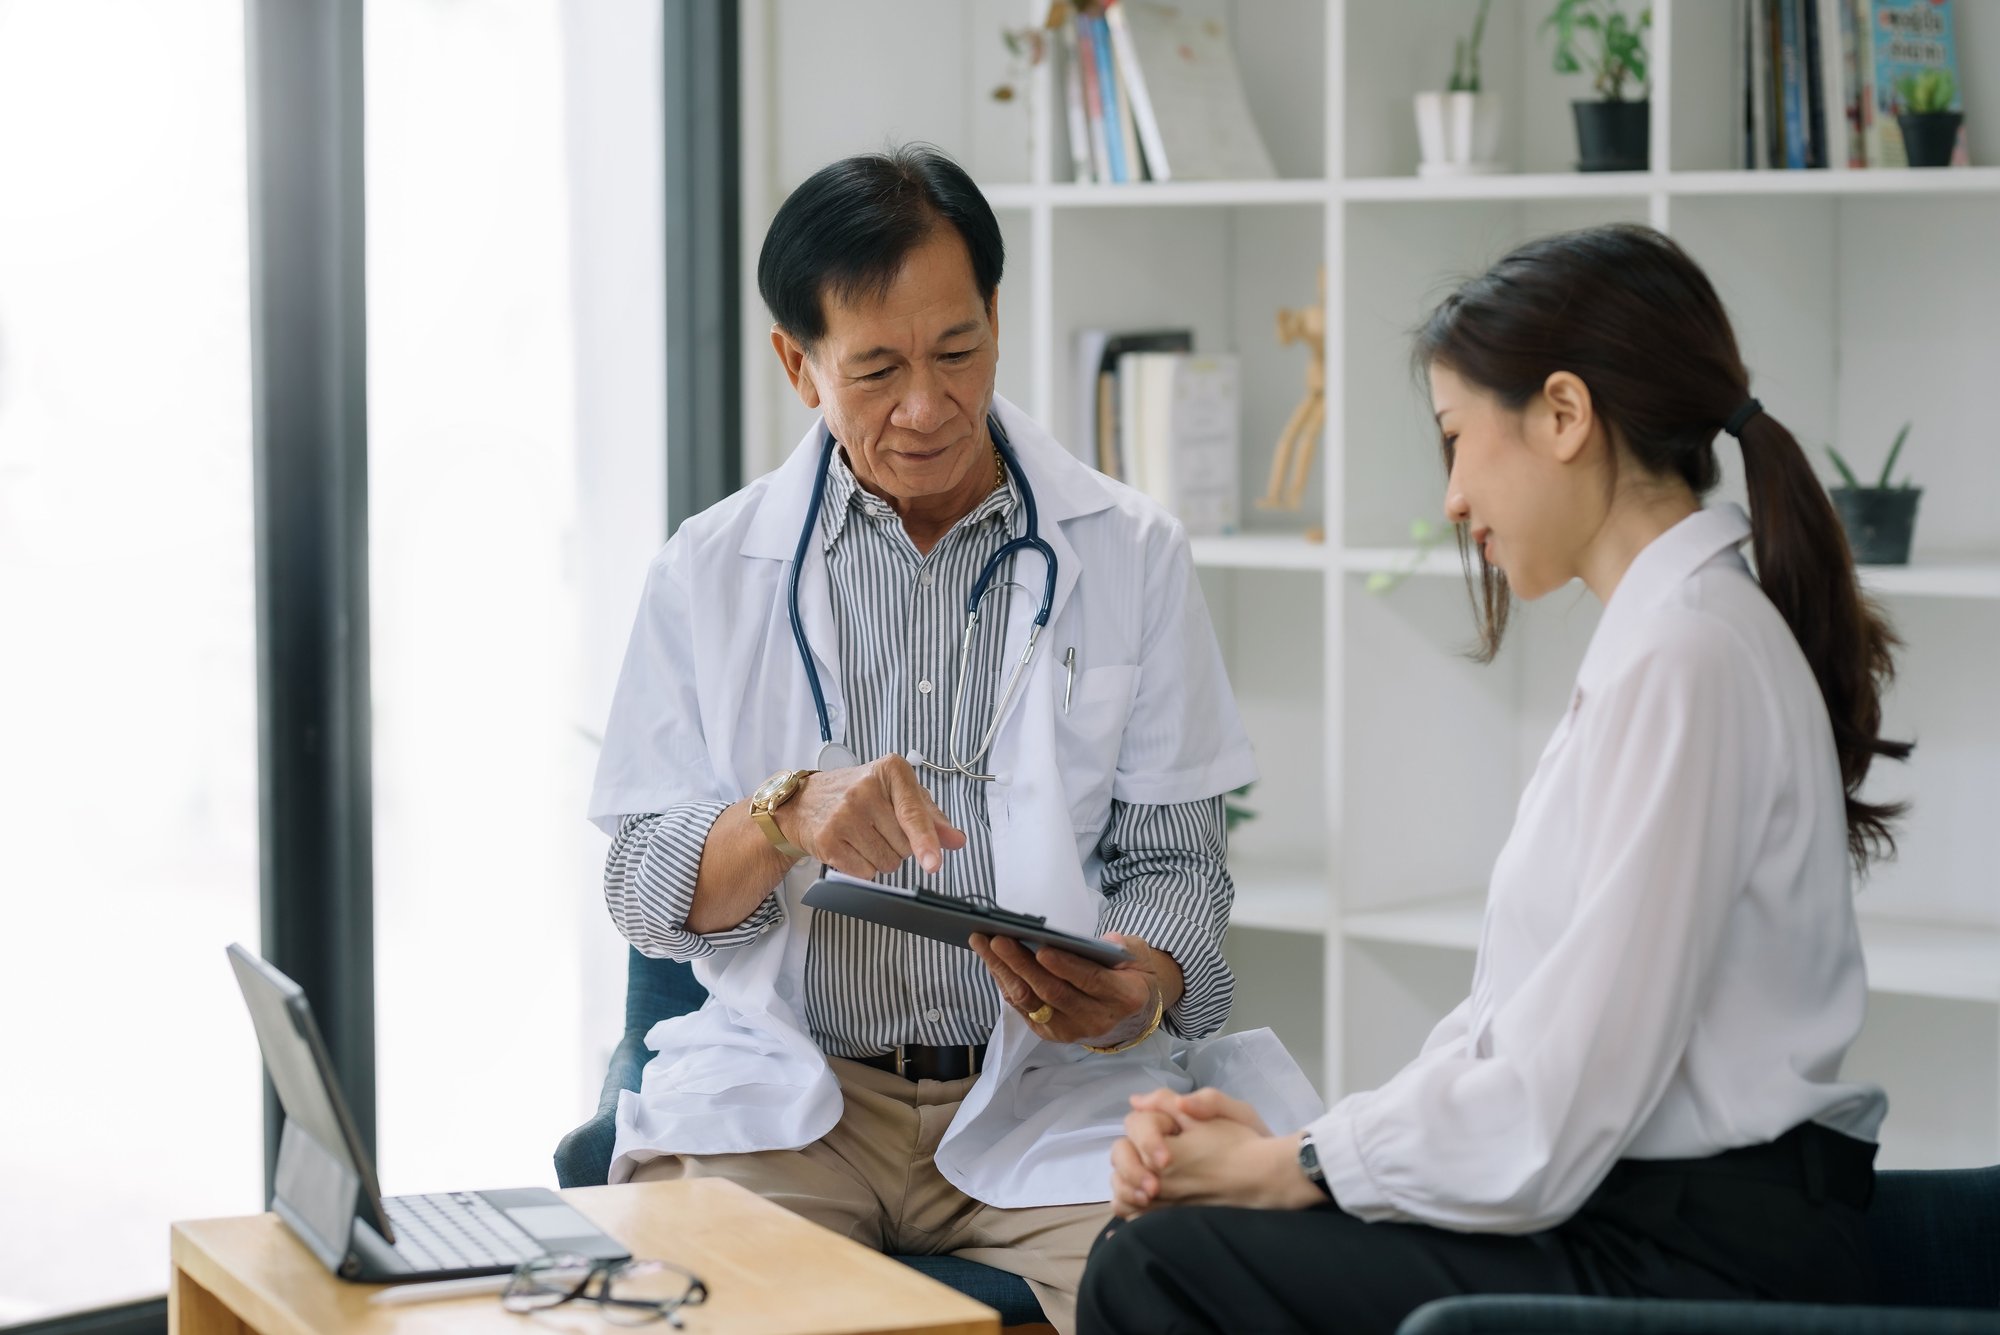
(756, 144), (1006, 348)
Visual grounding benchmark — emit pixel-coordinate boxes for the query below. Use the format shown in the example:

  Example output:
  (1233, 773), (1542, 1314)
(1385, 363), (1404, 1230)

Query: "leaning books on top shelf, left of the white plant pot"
(1050, 0), (1276, 184)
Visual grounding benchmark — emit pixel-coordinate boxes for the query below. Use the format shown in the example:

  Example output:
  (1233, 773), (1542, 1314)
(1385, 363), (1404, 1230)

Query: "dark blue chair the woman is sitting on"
(1398, 1165), (2000, 1335)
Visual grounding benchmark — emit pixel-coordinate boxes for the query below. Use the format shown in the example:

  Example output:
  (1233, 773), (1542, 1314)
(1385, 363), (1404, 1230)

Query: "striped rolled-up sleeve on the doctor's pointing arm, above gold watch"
(604, 801), (780, 959)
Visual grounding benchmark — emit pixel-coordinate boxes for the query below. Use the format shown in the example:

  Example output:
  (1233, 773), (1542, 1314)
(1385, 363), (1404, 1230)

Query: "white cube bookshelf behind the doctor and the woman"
(744, 0), (2000, 1167)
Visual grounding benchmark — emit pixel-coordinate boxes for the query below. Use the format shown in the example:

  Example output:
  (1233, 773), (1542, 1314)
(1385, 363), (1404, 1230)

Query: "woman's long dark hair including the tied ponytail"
(1416, 224), (1910, 867)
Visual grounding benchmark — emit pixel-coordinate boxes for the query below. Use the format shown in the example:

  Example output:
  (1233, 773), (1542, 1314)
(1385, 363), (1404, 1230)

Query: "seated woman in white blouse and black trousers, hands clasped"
(1080, 226), (1910, 1335)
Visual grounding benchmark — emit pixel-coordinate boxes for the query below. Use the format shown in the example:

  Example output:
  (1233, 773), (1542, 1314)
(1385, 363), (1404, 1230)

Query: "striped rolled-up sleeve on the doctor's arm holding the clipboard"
(1098, 797), (1236, 1039)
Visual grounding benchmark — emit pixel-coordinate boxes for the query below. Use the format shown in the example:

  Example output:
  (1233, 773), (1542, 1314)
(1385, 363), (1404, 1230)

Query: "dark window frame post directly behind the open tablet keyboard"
(244, 0), (376, 1193)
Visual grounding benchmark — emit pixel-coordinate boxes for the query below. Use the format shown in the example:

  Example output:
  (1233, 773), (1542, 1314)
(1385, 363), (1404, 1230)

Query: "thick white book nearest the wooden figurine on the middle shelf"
(1118, 352), (1240, 538)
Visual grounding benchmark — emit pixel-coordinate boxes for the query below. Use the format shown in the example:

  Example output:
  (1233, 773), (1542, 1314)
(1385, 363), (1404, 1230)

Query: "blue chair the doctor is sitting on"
(556, 949), (1042, 1325)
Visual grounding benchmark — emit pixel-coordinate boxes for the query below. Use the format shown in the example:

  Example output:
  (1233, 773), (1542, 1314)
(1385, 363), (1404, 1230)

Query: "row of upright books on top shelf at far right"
(1734, 0), (1968, 170)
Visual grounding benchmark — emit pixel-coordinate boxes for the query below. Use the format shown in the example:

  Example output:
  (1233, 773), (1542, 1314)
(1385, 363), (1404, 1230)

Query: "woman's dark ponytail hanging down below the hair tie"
(1738, 414), (1910, 867)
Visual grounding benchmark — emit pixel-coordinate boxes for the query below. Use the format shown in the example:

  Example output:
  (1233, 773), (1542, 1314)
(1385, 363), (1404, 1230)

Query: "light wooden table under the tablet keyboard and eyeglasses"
(168, 1179), (1000, 1335)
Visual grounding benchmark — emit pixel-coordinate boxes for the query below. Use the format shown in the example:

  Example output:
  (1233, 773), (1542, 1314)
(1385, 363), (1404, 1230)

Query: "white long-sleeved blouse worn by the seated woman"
(1310, 506), (1888, 1233)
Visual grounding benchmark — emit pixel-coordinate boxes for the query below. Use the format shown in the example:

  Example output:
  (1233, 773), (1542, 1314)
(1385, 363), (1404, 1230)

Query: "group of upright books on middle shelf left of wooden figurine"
(1070, 330), (1240, 538)
